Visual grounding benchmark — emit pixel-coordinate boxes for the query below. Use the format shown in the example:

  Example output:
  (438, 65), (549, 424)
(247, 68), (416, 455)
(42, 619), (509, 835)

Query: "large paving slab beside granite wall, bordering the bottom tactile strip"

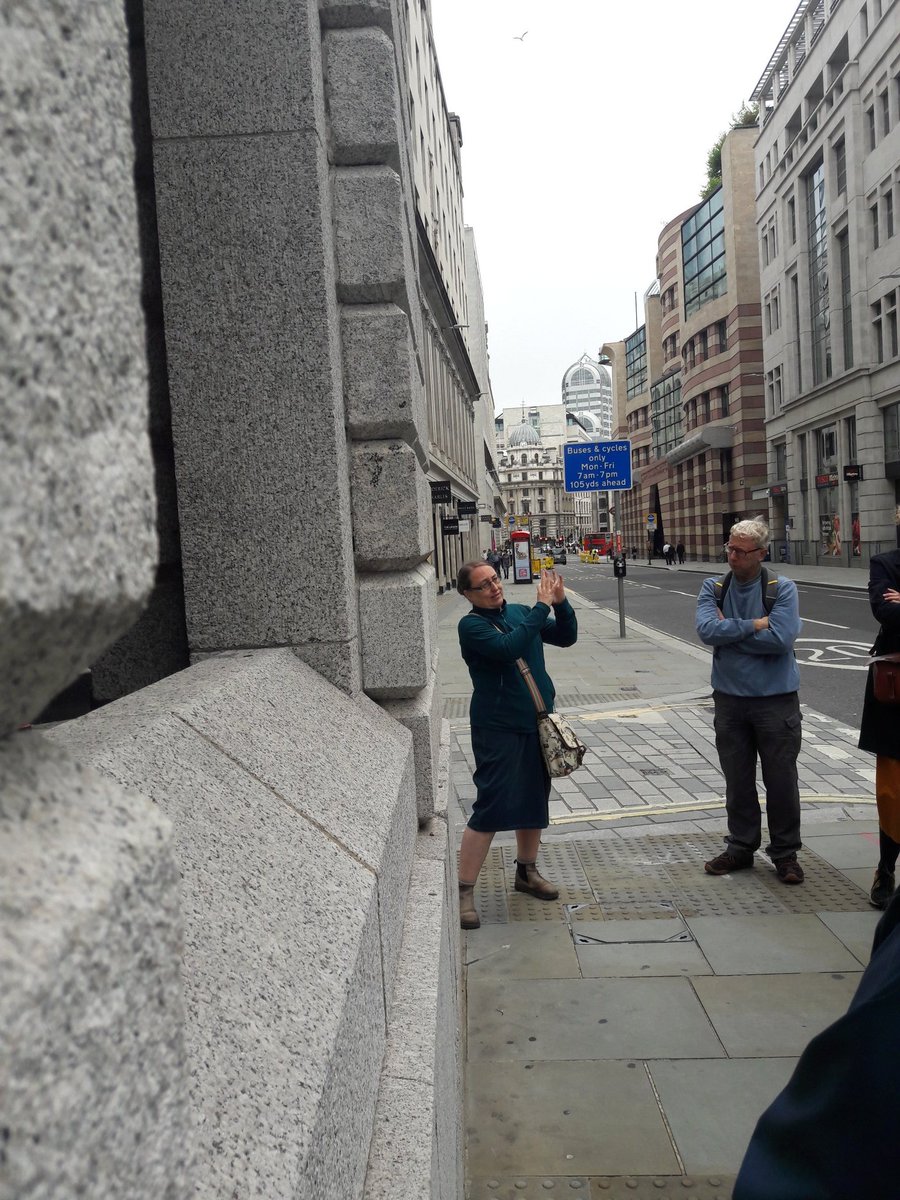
(467, 1062), (680, 1176)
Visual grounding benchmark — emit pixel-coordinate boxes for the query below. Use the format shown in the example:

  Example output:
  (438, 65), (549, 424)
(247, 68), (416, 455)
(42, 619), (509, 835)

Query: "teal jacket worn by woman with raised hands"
(458, 600), (578, 733)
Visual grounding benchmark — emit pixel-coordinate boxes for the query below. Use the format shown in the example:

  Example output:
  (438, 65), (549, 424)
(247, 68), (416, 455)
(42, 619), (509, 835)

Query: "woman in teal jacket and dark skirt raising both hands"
(456, 563), (578, 929)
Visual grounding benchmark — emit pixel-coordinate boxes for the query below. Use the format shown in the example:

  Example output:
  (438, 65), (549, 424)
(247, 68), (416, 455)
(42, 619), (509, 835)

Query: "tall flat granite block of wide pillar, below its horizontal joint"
(154, 134), (356, 652)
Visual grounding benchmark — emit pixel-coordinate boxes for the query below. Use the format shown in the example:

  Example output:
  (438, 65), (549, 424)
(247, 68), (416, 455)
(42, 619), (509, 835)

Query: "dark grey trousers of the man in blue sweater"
(713, 691), (802, 862)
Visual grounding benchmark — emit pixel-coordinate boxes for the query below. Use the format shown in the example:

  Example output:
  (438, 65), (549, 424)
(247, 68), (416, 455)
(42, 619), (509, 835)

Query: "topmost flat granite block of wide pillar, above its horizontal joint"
(144, 0), (324, 144)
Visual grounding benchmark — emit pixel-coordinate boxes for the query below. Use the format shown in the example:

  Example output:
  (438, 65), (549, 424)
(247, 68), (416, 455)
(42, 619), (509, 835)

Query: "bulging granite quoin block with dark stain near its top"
(350, 442), (431, 571)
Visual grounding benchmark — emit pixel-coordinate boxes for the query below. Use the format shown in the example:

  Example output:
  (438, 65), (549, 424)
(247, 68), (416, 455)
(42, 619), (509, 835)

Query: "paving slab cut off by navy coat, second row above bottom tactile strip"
(696, 971), (862, 1058)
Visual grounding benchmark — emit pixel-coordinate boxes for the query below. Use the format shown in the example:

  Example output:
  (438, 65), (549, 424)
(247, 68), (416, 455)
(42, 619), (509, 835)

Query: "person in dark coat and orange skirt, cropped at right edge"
(859, 537), (900, 908)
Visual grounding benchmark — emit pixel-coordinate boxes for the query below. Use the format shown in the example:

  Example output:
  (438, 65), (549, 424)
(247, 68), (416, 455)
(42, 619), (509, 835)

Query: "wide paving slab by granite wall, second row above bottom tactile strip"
(468, 979), (724, 1062)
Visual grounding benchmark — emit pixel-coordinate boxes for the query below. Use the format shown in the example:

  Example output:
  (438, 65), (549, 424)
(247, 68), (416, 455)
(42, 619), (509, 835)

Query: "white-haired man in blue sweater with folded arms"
(696, 518), (803, 883)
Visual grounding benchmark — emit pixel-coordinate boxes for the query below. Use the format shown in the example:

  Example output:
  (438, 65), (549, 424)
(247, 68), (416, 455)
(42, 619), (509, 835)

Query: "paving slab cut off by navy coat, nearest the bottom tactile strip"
(647, 1058), (797, 1175)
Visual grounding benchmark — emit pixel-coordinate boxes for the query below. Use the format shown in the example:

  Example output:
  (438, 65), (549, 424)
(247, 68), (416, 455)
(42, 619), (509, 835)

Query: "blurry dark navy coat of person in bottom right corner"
(732, 888), (900, 1200)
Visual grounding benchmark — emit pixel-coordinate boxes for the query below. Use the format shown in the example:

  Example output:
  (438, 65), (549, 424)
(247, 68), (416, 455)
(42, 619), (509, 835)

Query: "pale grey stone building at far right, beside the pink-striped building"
(754, 0), (900, 566)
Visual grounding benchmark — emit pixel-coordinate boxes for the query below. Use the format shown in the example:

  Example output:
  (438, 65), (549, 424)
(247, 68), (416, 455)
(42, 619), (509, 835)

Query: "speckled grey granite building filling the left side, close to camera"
(0, 0), (472, 1200)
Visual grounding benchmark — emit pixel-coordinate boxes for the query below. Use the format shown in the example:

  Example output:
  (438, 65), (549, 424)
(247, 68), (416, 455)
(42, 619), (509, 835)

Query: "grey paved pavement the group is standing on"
(438, 563), (880, 1200)
